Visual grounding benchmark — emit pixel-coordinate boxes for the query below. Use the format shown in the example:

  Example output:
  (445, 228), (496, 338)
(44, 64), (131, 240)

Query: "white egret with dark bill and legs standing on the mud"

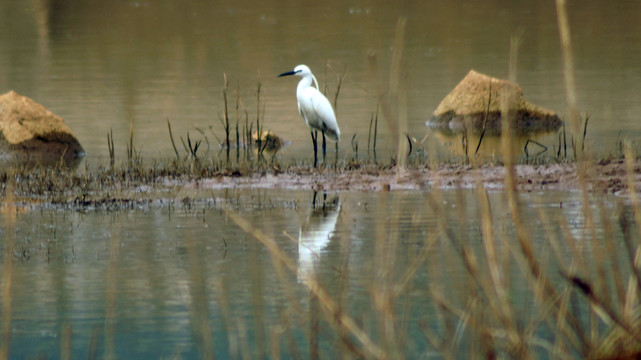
(278, 65), (341, 167)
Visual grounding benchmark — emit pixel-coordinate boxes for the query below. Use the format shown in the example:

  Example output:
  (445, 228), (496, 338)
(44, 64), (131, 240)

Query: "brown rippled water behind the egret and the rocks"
(0, 0), (641, 162)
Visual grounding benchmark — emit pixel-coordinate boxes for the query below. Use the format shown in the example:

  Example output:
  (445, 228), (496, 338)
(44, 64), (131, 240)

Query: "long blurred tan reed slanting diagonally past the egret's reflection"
(225, 211), (388, 359)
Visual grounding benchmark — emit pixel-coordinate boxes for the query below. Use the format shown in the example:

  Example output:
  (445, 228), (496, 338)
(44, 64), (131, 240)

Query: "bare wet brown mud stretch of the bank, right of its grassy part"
(189, 160), (641, 195)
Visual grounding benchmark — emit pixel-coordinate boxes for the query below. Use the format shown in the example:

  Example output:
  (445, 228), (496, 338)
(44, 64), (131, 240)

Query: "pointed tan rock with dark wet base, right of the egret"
(425, 70), (563, 136)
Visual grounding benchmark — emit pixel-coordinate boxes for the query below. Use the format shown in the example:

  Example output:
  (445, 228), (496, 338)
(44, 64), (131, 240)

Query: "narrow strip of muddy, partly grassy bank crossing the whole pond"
(0, 159), (641, 210)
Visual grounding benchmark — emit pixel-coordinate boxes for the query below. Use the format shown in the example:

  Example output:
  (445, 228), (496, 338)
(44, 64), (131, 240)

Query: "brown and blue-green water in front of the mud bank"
(0, 190), (632, 358)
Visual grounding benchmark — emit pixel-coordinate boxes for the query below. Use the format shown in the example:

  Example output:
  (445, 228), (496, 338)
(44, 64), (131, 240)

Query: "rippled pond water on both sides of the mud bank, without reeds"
(0, 0), (641, 358)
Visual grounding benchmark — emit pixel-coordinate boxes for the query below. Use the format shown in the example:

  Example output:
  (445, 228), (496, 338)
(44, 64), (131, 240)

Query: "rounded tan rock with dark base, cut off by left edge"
(0, 91), (85, 162)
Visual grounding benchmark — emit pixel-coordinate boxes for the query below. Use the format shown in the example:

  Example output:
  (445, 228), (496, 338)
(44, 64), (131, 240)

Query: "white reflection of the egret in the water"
(298, 191), (340, 282)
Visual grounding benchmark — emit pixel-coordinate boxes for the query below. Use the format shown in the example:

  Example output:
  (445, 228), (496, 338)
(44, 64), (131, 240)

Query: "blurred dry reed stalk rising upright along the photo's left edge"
(0, 181), (17, 360)
